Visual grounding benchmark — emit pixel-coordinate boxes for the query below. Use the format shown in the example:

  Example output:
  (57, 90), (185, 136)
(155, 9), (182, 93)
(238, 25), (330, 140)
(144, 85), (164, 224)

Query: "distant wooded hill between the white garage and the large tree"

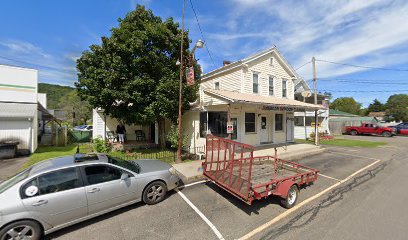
(38, 83), (74, 109)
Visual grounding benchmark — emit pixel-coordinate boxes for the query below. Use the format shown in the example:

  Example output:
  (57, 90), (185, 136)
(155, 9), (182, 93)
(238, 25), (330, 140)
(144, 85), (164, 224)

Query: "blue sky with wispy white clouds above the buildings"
(0, 0), (408, 106)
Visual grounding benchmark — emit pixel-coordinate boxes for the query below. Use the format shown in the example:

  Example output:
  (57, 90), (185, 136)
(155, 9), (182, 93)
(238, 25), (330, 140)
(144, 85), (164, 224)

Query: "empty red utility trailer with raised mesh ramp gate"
(203, 135), (319, 208)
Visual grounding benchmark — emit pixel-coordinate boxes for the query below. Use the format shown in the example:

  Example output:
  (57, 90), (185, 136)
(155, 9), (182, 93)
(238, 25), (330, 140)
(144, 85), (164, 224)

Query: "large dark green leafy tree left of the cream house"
(76, 5), (201, 144)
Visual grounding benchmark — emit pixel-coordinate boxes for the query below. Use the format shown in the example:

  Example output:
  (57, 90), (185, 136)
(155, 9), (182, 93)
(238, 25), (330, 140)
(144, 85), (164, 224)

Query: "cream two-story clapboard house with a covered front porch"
(182, 47), (324, 150)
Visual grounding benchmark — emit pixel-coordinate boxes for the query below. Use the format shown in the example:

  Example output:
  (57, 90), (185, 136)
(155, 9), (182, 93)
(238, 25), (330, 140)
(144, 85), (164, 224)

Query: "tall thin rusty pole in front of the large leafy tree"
(176, 0), (186, 163)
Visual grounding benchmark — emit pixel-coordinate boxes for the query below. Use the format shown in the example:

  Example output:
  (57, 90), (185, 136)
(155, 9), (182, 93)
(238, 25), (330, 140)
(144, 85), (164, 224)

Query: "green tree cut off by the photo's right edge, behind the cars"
(385, 94), (408, 122)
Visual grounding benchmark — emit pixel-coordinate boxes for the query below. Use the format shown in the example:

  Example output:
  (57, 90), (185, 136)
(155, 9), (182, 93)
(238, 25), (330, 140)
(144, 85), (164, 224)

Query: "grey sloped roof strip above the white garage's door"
(0, 102), (38, 118)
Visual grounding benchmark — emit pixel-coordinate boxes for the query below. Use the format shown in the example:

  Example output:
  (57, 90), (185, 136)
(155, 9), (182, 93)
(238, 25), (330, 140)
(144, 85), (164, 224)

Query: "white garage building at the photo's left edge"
(0, 65), (47, 153)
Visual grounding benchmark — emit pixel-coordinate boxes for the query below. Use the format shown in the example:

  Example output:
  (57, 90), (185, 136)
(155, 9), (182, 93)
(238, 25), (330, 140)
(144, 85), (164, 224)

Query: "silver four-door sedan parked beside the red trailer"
(0, 154), (180, 240)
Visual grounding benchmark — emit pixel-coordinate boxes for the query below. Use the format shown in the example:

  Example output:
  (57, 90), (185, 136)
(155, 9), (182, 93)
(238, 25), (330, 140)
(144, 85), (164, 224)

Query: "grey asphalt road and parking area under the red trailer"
(47, 136), (408, 239)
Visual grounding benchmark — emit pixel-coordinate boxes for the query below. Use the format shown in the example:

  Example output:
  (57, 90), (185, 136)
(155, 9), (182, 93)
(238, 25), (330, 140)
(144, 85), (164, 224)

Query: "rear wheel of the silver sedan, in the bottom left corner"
(0, 220), (43, 240)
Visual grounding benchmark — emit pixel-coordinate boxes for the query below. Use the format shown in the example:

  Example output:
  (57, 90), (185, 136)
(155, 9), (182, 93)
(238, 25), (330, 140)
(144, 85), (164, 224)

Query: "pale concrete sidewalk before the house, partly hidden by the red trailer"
(173, 144), (325, 184)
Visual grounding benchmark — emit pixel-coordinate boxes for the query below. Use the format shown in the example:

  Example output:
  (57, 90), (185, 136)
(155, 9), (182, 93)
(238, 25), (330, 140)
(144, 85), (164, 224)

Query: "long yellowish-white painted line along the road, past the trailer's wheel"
(240, 159), (381, 240)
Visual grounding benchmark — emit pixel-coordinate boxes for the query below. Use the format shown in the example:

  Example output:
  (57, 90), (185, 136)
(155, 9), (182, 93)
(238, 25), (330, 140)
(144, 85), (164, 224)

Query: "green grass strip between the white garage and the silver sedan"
(22, 144), (92, 169)
